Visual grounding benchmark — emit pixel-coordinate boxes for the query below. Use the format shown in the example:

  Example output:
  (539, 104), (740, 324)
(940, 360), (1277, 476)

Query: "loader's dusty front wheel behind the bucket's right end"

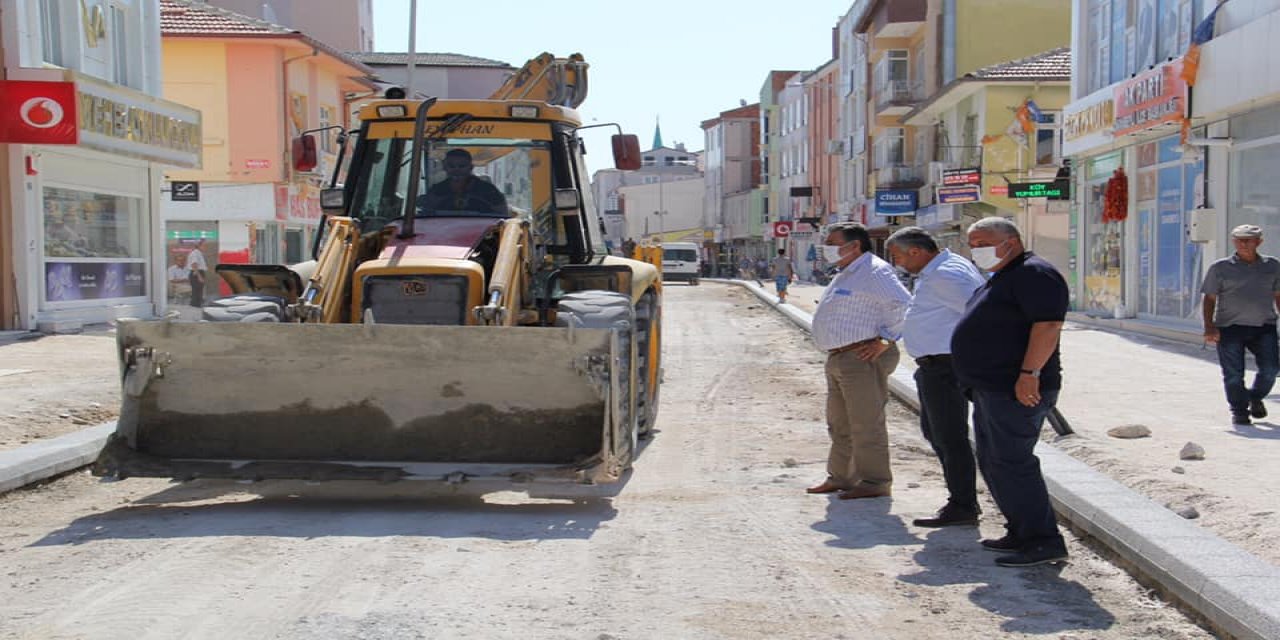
(556, 291), (636, 468)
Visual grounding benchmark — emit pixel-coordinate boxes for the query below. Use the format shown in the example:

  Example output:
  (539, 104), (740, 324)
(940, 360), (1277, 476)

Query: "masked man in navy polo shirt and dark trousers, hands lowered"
(951, 218), (1068, 567)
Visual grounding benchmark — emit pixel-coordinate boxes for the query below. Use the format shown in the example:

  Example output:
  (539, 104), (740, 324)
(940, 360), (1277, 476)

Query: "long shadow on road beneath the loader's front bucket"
(32, 481), (617, 547)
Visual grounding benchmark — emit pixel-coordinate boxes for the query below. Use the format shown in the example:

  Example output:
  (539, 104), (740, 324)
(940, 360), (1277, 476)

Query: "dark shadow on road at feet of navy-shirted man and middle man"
(899, 527), (1116, 635)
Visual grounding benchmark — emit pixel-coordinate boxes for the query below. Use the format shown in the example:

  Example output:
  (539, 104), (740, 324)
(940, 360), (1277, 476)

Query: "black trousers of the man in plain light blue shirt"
(915, 355), (978, 512)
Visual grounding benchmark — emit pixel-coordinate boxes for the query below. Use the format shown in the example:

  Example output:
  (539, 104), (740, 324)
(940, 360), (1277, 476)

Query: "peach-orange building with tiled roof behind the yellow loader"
(160, 0), (375, 303)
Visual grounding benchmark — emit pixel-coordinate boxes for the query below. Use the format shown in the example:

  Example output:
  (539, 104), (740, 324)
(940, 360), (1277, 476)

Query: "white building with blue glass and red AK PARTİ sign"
(1064, 0), (1280, 330)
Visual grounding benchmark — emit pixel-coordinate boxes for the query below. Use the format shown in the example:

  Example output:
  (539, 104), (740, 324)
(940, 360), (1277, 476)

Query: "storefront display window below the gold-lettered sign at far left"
(44, 187), (147, 302)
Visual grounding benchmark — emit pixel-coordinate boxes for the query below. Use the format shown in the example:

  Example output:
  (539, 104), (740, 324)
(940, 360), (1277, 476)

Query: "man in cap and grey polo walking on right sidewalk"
(1201, 224), (1280, 425)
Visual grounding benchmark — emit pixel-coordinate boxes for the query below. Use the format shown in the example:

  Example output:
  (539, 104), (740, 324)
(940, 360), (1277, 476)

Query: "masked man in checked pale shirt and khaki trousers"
(806, 223), (911, 499)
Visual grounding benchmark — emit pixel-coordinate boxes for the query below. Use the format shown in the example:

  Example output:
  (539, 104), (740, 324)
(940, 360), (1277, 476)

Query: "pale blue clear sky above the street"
(374, 0), (852, 172)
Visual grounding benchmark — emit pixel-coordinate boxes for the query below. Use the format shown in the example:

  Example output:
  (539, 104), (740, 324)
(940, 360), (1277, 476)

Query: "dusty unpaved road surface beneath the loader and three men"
(0, 284), (1211, 640)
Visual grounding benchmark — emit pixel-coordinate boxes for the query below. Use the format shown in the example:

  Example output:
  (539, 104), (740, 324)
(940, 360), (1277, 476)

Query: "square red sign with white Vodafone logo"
(0, 81), (79, 145)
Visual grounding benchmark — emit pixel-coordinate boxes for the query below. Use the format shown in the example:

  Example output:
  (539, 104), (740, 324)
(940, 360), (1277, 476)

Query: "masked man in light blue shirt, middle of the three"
(886, 227), (986, 527)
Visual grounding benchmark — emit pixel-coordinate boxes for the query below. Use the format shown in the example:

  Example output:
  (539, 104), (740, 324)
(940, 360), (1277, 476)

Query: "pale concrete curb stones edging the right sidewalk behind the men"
(708, 279), (1280, 640)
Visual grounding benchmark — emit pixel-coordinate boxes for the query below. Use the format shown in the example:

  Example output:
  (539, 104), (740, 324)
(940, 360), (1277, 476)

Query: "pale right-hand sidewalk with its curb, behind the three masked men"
(736, 282), (1280, 639)
